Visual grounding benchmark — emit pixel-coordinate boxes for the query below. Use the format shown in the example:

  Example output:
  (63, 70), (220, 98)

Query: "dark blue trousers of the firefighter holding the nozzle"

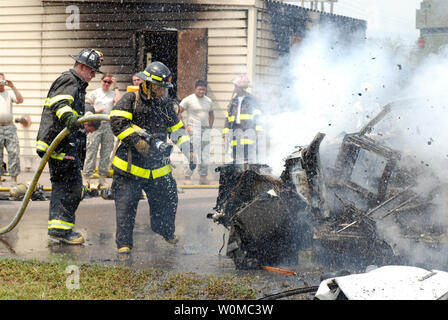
(112, 173), (178, 248)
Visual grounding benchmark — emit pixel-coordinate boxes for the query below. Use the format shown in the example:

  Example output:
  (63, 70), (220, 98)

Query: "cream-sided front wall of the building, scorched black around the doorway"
(0, 0), (252, 167)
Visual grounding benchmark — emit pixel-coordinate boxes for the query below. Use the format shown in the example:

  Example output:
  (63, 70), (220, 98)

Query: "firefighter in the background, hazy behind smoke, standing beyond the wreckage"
(222, 74), (263, 164)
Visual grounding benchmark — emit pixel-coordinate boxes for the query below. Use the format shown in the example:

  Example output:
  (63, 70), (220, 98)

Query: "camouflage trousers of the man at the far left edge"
(0, 124), (20, 177)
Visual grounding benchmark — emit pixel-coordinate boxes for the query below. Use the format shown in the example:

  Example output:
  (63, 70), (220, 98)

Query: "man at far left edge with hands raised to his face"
(0, 73), (23, 186)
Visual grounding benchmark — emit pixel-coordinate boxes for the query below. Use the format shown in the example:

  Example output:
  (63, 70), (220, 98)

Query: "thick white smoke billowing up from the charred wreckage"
(255, 22), (448, 268)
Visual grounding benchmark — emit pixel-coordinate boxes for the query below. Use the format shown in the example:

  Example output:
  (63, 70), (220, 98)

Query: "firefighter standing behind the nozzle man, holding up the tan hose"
(36, 49), (103, 244)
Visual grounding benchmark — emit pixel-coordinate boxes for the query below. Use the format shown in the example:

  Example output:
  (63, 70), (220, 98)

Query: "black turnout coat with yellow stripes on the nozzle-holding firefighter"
(110, 92), (190, 179)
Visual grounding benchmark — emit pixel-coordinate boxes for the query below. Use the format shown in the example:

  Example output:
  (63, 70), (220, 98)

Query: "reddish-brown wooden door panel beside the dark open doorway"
(177, 29), (208, 100)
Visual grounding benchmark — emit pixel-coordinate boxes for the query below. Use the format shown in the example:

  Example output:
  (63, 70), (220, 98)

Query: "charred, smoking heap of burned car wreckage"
(207, 103), (445, 269)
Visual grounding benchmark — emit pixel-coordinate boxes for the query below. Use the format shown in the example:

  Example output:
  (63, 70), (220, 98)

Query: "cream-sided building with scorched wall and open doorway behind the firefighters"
(0, 0), (366, 170)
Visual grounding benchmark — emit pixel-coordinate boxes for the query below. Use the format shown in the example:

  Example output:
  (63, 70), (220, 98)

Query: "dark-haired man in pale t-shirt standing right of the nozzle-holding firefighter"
(179, 80), (215, 184)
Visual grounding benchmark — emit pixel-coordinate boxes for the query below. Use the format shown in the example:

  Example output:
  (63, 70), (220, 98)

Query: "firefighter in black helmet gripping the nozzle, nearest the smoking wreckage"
(110, 61), (194, 254)
